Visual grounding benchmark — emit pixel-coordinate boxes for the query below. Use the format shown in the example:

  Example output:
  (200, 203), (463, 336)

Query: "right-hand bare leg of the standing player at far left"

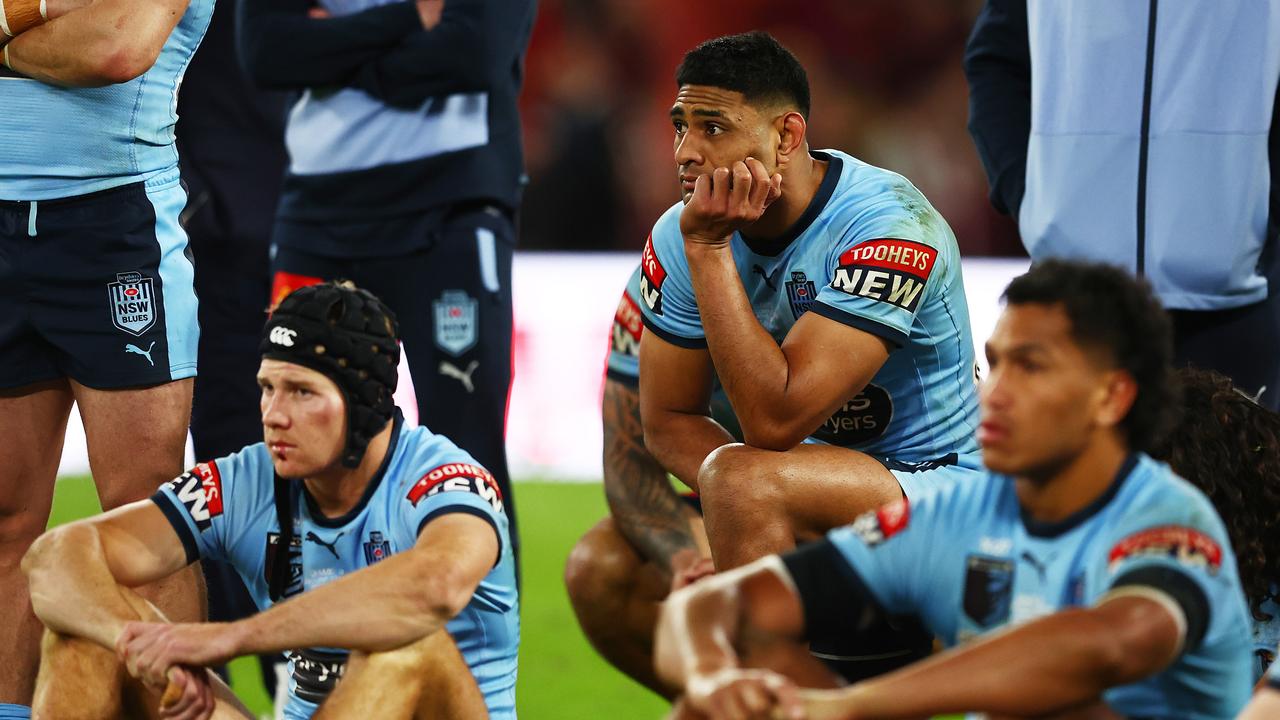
(72, 378), (206, 621)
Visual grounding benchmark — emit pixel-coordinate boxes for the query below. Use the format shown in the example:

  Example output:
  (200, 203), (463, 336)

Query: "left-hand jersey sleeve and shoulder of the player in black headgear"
(151, 454), (264, 562)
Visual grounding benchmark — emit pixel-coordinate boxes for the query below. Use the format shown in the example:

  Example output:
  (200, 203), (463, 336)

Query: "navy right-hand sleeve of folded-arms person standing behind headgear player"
(348, 0), (494, 109)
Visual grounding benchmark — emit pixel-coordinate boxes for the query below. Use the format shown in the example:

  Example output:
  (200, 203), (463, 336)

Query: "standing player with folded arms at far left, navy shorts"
(0, 0), (214, 719)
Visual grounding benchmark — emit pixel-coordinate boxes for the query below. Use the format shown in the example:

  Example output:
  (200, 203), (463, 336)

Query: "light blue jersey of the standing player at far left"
(0, 0), (214, 201)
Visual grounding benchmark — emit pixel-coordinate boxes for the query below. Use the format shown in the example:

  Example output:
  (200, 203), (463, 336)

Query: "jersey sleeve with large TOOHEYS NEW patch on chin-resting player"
(813, 181), (950, 347)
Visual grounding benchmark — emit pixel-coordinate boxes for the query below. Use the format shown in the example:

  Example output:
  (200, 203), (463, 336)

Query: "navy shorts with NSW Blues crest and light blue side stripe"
(0, 172), (200, 389)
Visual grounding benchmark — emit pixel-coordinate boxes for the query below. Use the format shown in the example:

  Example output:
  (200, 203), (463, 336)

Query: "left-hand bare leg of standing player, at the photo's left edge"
(0, 380), (72, 705)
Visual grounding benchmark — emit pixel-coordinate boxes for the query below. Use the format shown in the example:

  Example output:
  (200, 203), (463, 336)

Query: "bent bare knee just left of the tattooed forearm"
(564, 518), (640, 615)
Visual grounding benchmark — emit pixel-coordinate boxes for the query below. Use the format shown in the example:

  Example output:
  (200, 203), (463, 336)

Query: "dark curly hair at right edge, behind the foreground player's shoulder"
(1151, 368), (1280, 621)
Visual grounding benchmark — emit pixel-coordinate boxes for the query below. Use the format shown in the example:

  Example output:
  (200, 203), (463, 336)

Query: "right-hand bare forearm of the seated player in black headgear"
(233, 545), (456, 655)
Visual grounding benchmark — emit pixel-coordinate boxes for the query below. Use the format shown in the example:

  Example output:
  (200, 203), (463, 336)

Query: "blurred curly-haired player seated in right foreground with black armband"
(657, 261), (1249, 719)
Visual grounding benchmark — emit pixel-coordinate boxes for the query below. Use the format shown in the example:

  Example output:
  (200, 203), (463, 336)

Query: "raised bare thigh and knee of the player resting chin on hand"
(698, 445), (902, 570)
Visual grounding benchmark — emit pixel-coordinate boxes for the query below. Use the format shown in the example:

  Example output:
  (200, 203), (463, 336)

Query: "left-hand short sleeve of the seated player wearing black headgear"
(151, 459), (236, 562)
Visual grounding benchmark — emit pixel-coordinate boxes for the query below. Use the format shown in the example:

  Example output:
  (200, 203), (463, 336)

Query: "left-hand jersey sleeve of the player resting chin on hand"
(639, 204), (707, 348)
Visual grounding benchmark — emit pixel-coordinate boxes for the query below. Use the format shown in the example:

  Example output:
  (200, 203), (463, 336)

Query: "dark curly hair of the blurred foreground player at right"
(1002, 260), (1178, 452)
